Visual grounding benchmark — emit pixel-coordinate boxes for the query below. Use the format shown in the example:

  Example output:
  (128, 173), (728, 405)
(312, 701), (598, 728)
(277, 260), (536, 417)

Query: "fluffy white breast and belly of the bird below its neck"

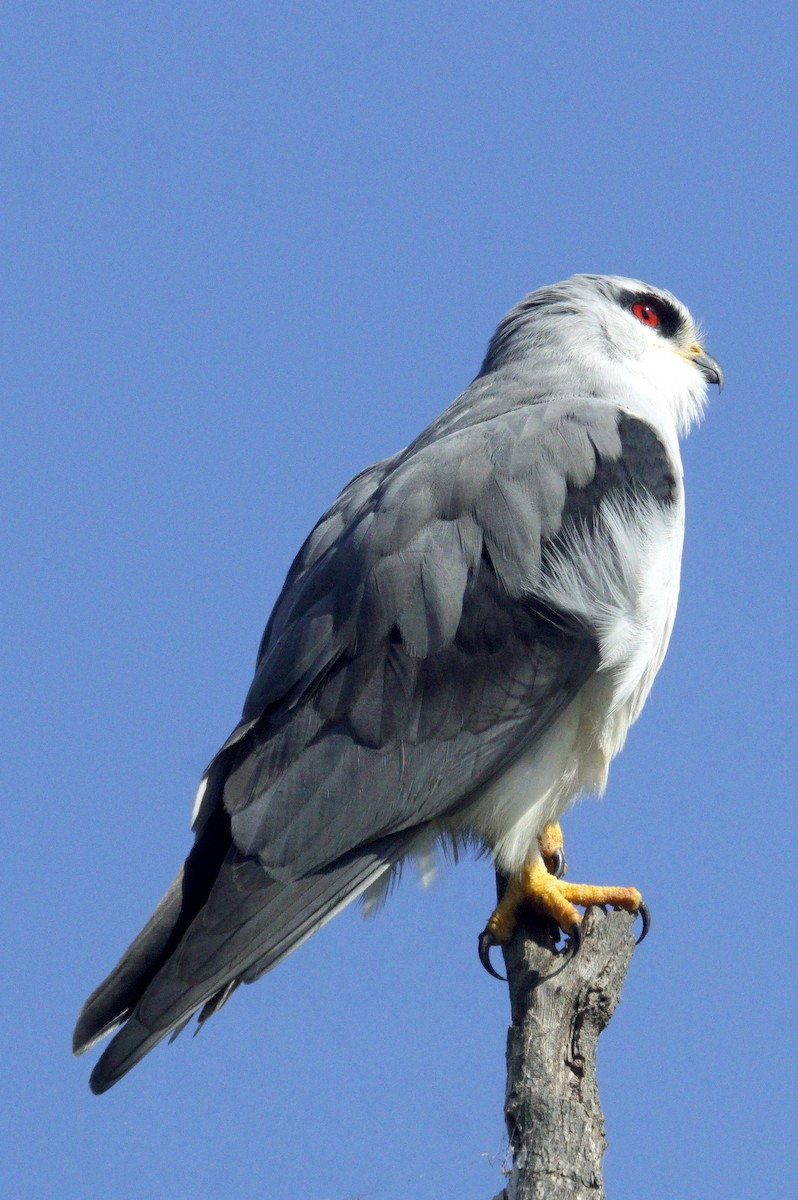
(466, 496), (684, 874)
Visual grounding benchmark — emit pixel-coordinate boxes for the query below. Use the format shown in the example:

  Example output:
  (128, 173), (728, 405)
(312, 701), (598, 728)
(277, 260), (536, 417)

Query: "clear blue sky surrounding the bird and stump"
(0, 0), (798, 1200)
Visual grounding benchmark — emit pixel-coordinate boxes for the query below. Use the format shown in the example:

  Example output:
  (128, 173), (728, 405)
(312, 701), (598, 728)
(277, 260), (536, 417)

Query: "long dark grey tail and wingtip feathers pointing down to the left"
(74, 830), (413, 1092)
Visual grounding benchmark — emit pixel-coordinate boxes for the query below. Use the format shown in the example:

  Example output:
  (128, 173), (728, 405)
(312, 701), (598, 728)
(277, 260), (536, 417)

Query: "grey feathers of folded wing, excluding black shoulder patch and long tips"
(216, 400), (661, 881)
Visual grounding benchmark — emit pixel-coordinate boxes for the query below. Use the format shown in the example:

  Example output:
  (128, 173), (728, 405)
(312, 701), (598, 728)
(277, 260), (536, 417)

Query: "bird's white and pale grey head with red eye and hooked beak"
(480, 275), (724, 433)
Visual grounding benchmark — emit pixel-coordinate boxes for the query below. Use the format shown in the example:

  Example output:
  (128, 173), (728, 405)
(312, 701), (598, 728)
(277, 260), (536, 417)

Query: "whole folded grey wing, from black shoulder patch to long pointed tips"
(76, 386), (673, 1091)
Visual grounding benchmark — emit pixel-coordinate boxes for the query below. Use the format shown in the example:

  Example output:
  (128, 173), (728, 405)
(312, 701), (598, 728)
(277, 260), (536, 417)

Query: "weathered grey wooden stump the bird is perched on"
(494, 908), (635, 1200)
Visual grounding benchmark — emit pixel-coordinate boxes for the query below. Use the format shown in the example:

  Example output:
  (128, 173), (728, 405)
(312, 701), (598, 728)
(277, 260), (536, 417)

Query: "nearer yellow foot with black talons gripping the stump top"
(479, 859), (650, 979)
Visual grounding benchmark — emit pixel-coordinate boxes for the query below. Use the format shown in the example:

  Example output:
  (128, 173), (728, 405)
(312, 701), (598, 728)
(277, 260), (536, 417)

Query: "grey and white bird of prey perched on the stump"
(74, 275), (722, 1092)
